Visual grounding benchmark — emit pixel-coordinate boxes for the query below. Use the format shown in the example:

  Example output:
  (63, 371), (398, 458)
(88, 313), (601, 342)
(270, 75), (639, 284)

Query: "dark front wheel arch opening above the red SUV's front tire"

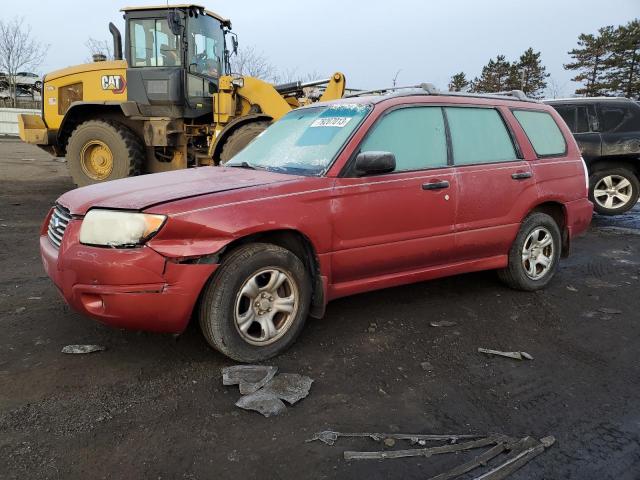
(218, 229), (327, 318)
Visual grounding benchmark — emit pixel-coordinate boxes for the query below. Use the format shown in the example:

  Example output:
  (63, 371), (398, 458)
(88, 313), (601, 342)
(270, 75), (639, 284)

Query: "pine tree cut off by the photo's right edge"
(603, 19), (640, 98)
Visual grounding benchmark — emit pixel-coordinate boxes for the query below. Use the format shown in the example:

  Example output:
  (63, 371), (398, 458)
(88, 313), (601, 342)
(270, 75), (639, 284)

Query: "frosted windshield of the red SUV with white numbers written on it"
(227, 104), (371, 175)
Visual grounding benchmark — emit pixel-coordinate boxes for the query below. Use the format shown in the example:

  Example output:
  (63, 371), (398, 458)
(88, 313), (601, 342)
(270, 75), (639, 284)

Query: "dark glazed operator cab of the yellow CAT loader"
(123, 5), (231, 118)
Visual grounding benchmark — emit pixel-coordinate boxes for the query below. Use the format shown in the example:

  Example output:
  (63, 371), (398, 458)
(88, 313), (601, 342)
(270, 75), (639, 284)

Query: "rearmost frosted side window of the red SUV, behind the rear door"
(513, 110), (567, 157)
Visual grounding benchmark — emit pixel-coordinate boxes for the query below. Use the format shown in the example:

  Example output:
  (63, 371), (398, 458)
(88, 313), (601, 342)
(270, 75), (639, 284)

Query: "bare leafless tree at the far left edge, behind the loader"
(0, 17), (48, 107)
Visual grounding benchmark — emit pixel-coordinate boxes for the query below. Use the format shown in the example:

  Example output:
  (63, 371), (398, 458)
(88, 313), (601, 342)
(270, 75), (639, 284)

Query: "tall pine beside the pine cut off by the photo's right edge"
(564, 26), (614, 97)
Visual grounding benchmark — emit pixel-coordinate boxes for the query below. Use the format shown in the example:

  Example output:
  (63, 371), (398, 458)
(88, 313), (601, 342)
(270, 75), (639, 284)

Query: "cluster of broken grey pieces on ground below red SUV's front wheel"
(222, 365), (313, 417)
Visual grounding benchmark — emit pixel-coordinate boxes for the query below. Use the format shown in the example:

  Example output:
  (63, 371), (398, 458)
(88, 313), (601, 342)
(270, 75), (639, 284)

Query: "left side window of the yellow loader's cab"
(129, 18), (182, 67)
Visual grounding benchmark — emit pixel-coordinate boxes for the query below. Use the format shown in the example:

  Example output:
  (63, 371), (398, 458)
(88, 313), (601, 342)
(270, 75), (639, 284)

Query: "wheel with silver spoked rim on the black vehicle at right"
(589, 168), (640, 215)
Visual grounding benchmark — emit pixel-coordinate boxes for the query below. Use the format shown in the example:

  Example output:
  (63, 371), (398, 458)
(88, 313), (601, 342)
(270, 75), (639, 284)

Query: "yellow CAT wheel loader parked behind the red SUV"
(18, 5), (345, 186)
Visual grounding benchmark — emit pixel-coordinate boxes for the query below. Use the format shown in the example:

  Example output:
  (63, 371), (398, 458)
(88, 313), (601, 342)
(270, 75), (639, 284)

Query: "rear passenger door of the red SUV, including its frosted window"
(445, 106), (537, 260)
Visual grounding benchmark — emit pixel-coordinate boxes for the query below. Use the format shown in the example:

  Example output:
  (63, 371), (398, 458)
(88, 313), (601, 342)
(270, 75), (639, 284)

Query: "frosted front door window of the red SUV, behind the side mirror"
(360, 107), (447, 171)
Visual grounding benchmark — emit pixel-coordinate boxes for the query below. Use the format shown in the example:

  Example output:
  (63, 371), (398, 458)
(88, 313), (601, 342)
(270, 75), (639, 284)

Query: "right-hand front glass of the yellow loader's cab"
(189, 15), (224, 78)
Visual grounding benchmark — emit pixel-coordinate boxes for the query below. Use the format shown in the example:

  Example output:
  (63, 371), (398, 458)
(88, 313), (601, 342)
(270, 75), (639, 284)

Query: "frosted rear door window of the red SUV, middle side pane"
(445, 107), (518, 165)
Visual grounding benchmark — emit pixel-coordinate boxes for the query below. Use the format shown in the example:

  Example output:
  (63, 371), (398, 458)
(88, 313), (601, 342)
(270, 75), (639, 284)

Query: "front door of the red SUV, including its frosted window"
(332, 106), (456, 284)
